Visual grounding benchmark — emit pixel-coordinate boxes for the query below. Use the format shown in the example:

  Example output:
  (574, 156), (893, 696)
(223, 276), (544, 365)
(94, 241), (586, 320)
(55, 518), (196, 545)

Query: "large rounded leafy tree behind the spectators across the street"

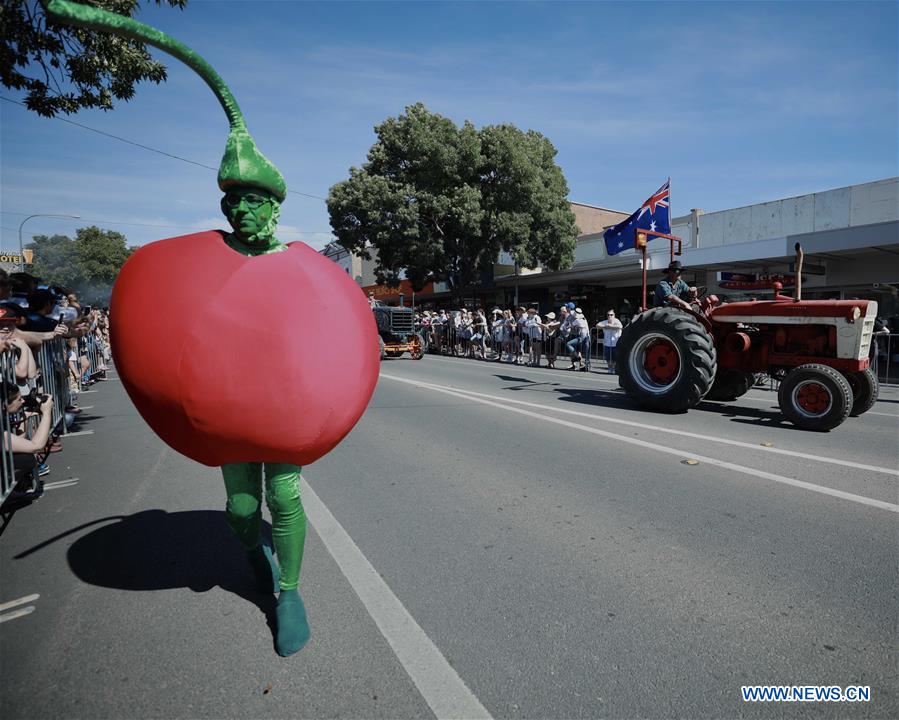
(328, 103), (577, 297)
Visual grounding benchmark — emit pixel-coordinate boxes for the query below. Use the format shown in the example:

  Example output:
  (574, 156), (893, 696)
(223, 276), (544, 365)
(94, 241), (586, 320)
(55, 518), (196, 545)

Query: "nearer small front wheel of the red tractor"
(777, 363), (852, 431)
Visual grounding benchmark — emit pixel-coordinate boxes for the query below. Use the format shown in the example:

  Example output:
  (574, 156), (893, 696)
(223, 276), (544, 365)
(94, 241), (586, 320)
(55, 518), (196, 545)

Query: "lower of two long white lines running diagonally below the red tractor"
(381, 374), (899, 513)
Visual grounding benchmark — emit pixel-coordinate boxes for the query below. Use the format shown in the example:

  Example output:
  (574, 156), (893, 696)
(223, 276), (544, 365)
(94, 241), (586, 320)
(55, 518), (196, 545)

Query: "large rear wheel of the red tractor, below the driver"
(618, 308), (717, 412)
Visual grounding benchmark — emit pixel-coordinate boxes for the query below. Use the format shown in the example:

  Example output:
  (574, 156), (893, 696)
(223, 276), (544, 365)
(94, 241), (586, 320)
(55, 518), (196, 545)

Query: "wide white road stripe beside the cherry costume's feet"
(302, 478), (490, 720)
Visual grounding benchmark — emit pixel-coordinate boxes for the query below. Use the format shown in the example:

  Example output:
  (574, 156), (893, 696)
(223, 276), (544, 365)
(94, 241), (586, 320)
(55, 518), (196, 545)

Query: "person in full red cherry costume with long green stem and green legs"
(47, 0), (379, 656)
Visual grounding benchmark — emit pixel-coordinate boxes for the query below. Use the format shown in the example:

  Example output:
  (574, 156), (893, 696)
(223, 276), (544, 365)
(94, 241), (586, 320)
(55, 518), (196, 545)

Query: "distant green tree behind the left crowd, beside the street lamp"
(27, 226), (135, 304)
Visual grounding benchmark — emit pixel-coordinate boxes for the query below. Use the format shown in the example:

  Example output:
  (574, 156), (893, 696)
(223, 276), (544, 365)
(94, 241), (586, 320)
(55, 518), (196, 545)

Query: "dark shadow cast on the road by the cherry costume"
(16, 510), (275, 648)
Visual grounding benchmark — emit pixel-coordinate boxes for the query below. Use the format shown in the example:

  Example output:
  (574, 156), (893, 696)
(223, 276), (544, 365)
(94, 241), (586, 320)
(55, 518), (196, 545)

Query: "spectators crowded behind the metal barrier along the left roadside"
(0, 269), (110, 510)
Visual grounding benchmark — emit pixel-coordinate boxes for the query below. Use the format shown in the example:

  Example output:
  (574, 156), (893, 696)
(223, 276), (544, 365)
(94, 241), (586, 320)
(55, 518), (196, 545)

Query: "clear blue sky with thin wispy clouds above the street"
(0, 0), (899, 249)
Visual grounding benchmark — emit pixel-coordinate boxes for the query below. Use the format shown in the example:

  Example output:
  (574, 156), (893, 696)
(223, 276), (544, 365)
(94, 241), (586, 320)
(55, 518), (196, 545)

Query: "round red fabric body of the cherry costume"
(110, 231), (380, 466)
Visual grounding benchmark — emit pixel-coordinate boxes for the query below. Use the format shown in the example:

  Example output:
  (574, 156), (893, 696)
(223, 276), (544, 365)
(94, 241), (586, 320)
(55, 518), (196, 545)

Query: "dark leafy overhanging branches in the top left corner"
(0, 0), (187, 117)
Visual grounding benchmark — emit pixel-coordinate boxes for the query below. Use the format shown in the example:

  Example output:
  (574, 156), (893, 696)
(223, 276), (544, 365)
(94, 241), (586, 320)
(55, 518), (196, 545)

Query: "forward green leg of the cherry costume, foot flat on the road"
(265, 464), (310, 656)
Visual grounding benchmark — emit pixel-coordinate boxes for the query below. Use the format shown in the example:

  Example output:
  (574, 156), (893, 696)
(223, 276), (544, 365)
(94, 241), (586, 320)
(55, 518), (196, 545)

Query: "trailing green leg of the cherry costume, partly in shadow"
(222, 463), (280, 593)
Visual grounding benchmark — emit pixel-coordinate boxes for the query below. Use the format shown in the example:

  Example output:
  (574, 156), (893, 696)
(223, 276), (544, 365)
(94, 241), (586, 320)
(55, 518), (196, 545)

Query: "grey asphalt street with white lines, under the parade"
(0, 356), (899, 720)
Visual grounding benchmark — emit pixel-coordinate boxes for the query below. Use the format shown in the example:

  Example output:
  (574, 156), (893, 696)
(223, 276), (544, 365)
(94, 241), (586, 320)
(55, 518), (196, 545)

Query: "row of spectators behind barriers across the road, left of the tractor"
(415, 302), (623, 373)
